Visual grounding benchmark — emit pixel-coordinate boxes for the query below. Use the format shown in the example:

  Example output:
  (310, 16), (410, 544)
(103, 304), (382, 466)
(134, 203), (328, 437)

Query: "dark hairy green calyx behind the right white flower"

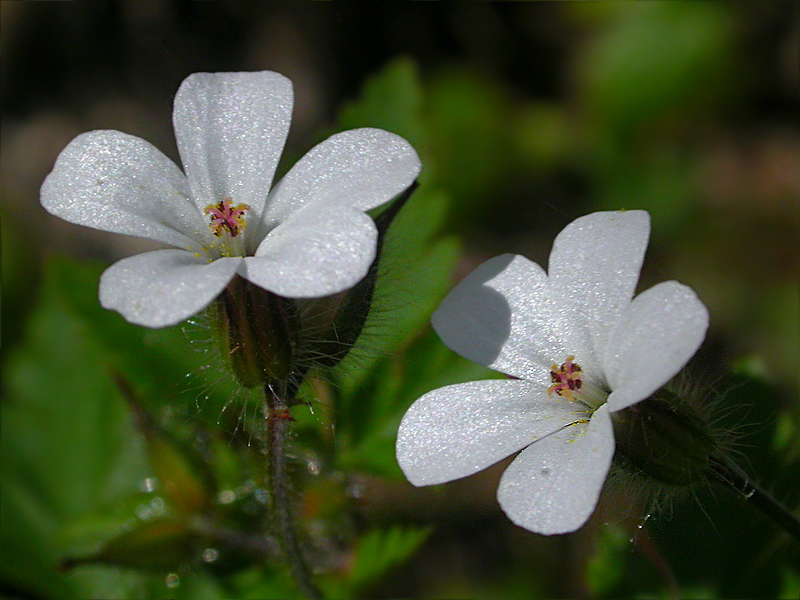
(614, 389), (715, 485)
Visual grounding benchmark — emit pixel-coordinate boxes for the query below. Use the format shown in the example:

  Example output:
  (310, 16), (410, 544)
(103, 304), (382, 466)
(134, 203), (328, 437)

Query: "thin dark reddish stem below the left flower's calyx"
(264, 383), (322, 598)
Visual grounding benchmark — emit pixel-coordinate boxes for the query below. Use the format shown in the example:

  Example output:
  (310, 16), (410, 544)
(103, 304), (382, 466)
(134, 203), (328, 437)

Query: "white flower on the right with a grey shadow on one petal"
(397, 210), (708, 534)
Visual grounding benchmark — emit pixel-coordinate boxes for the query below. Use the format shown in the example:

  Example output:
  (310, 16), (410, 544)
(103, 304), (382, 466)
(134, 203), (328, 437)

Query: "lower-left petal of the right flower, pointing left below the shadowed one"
(397, 380), (581, 485)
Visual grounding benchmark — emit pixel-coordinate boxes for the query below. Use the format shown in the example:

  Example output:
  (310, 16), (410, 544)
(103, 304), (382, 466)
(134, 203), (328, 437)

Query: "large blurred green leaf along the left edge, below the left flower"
(0, 262), (152, 598)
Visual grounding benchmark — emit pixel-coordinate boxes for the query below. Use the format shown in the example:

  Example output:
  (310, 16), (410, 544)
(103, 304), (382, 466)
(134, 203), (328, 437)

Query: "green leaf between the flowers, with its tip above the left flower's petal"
(333, 60), (491, 478)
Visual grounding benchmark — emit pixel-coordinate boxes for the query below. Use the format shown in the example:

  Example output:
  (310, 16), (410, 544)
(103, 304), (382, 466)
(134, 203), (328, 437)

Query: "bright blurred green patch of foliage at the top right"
(582, 2), (731, 143)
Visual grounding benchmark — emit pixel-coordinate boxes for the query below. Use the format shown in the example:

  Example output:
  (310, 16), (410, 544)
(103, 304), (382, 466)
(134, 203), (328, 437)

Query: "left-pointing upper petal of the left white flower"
(41, 131), (208, 250)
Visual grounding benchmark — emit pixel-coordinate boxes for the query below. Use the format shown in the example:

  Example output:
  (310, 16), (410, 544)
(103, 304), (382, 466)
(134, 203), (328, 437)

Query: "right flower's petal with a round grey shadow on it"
(431, 254), (566, 382)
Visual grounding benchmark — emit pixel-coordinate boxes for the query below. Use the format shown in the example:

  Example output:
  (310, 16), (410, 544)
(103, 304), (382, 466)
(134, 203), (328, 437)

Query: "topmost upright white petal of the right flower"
(548, 210), (650, 384)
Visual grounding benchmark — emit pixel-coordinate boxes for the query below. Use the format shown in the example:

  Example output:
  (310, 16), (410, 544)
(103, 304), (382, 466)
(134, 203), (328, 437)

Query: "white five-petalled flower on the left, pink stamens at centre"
(41, 71), (420, 327)
